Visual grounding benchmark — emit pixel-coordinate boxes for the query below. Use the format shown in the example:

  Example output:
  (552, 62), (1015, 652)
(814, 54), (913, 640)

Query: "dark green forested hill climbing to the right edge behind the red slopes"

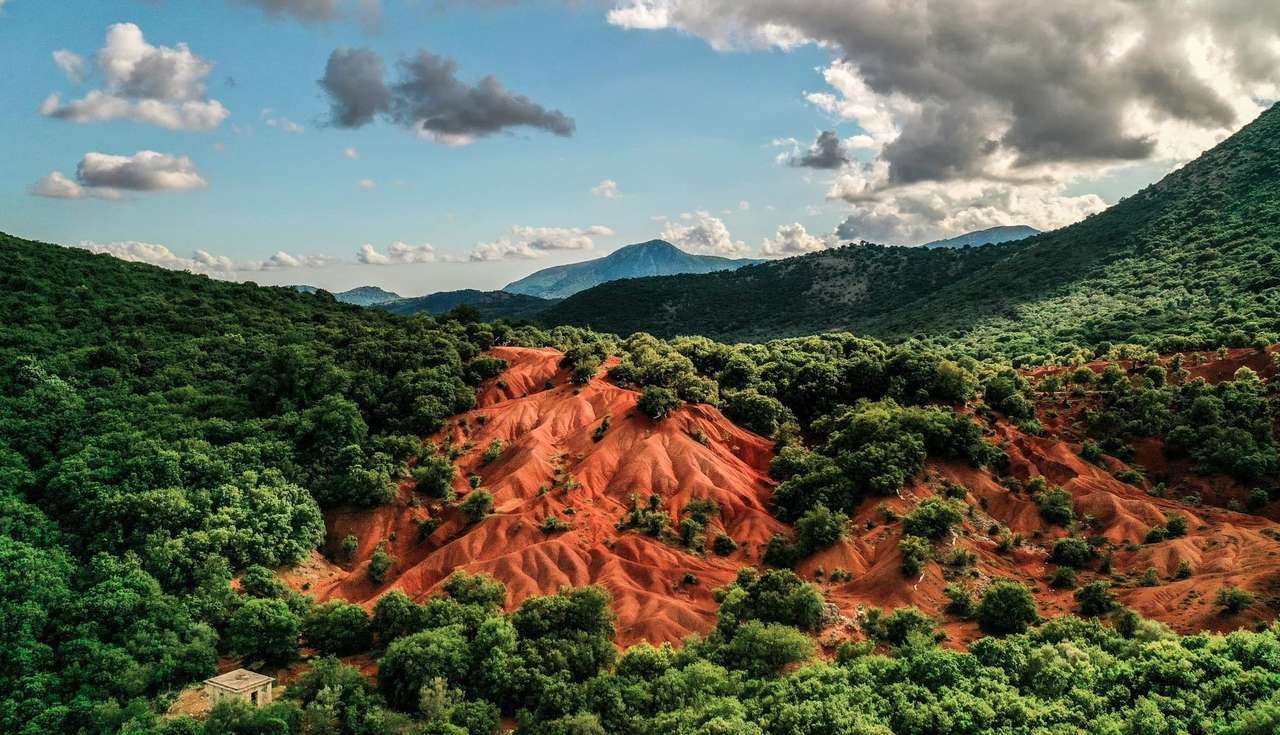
(547, 108), (1280, 357)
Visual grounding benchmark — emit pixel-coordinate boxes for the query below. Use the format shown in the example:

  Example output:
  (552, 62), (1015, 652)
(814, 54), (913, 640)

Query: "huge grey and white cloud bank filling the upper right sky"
(609, 0), (1280, 242)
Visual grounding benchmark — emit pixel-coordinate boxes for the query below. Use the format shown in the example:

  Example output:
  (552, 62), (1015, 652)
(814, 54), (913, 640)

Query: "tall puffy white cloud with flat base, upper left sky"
(40, 23), (228, 131)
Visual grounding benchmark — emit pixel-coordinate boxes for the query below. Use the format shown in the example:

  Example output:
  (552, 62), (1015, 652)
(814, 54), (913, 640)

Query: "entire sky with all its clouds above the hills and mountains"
(0, 0), (1280, 296)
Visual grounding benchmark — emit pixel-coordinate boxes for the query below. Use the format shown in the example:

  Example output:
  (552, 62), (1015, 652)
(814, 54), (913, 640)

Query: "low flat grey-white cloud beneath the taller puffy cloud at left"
(31, 151), (207, 198)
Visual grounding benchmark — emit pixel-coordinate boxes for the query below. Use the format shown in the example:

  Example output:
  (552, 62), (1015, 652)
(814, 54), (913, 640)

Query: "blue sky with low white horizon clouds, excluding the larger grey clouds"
(0, 0), (1257, 295)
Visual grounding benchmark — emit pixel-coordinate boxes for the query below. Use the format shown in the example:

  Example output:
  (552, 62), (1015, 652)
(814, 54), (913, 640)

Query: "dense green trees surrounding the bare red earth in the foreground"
(0, 230), (1280, 735)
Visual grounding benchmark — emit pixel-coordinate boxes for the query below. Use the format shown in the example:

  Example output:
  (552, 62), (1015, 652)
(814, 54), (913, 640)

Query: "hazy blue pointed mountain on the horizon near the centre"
(503, 239), (760, 298)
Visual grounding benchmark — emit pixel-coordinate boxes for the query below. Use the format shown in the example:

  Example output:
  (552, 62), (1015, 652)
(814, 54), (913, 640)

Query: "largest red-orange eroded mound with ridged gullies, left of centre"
(295, 347), (783, 643)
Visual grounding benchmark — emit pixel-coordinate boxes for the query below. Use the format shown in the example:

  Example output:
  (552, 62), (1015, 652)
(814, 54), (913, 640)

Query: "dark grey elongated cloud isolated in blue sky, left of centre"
(319, 47), (573, 145)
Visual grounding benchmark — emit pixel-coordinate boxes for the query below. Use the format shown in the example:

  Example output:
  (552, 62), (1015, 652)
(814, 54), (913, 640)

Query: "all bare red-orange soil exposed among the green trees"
(294, 347), (1280, 645)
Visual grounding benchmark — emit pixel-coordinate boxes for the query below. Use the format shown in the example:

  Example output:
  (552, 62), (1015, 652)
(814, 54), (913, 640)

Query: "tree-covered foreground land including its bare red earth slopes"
(0, 236), (1280, 735)
